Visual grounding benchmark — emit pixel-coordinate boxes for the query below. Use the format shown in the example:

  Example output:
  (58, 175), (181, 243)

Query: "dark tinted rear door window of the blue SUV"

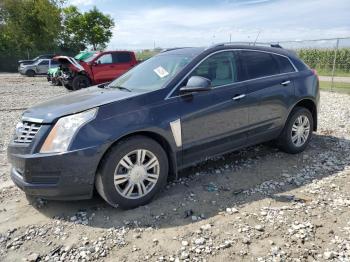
(241, 51), (280, 79)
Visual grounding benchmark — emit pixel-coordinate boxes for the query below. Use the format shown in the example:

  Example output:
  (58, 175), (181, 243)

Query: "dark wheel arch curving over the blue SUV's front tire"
(95, 131), (177, 184)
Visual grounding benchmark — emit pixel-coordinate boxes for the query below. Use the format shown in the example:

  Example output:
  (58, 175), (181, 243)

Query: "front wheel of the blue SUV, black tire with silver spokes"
(95, 136), (169, 209)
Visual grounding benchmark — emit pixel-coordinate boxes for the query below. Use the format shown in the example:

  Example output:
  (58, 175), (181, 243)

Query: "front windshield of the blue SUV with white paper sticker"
(109, 54), (193, 91)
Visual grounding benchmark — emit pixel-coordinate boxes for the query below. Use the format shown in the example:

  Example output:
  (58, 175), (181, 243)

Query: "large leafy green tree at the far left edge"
(0, 0), (61, 51)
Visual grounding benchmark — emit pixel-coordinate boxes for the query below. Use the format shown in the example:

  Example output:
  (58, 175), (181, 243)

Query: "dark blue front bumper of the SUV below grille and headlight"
(8, 145), (103, 200)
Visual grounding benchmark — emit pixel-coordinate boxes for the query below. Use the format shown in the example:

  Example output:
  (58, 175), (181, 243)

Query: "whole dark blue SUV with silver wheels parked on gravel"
(8, 44), (319, 208)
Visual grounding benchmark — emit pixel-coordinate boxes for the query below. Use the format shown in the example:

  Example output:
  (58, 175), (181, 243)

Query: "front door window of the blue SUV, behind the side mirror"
(189, 52), (238, 87)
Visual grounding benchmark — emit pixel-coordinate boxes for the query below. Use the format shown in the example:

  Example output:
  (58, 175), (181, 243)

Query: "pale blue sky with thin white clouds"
(69, 0), (350, 49)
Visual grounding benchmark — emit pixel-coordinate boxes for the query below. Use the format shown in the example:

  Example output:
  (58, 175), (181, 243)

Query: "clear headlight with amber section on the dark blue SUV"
(40, 108), (97, 153)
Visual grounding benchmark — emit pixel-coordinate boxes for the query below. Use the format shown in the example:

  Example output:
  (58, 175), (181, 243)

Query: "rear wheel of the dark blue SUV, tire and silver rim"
(278, 107), (314, 154)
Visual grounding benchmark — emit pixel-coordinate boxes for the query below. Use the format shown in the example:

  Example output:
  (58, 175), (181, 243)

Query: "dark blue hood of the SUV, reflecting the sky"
(23, 86), (140, 123)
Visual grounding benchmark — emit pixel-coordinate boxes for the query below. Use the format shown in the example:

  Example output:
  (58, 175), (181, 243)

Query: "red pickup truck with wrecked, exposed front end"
(53, 51), (138, 90)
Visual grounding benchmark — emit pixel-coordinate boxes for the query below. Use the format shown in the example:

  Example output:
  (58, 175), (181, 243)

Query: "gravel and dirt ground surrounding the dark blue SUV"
(0, 74), (350, 261)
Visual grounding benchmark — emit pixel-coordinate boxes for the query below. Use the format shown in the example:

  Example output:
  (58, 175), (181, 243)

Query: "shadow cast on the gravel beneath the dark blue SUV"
(34, 133), (350, 228)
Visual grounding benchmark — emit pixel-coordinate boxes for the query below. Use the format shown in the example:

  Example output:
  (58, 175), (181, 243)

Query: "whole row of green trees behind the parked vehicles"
(0, 0), (114, 70)
